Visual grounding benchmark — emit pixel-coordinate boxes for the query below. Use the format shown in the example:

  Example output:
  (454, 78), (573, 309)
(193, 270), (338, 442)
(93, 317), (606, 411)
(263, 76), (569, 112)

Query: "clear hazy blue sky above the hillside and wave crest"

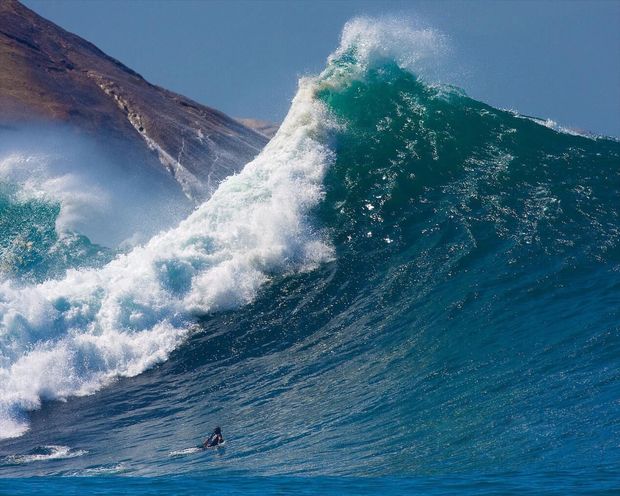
(22, 0), (620, 137)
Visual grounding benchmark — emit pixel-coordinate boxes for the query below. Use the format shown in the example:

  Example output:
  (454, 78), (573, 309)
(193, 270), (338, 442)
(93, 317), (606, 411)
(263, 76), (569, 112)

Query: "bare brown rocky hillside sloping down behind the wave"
(0, 0), (267, 201)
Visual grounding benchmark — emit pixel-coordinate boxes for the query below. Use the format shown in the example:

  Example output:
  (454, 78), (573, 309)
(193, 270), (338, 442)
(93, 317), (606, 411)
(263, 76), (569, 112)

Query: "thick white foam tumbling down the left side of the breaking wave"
(0, 79), (333, 438)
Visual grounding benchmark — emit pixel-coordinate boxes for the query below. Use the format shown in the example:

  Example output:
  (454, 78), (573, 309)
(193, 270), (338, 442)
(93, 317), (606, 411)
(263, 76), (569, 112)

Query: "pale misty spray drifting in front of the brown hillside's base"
(0, 130), (195, 252)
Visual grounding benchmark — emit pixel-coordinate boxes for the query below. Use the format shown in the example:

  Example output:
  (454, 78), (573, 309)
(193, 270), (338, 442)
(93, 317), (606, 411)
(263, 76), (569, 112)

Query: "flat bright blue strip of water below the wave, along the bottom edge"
(0, 473), (617, 496)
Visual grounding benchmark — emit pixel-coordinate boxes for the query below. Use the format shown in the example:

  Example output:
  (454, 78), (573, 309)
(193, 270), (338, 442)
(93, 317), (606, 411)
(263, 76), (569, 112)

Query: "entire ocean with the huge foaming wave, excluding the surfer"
(0, 19), (620, 494)
